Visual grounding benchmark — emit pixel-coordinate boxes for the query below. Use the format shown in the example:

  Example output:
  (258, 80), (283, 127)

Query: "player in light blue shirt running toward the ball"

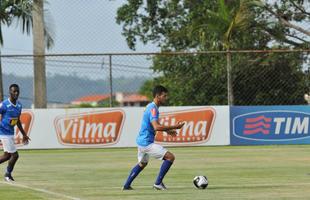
(123, 85), (184, 190)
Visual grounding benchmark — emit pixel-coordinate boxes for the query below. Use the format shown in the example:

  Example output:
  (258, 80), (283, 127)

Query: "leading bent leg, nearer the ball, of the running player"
(153, 144), (175, 190)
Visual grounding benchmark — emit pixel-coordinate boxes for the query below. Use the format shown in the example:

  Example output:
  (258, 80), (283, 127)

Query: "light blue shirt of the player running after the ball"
(136, 102), (159, 146)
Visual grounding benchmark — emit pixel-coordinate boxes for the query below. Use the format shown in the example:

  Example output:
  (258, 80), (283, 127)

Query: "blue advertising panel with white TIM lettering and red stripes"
(230, 106), (310, 145)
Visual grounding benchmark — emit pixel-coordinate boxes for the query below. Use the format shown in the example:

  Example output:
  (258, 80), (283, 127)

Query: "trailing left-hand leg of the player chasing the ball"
(123, 148), (149, 190)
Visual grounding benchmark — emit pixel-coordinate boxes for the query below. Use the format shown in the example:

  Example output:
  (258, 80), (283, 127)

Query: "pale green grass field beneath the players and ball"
(0, 145), (310, 200)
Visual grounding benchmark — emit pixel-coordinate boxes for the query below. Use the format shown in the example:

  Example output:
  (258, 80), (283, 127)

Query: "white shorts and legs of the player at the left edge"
(2, 137), (19, 181)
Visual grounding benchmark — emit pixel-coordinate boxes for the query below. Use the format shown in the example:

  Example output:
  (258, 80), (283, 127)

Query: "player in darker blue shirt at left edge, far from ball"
(0, 84), (30, 181)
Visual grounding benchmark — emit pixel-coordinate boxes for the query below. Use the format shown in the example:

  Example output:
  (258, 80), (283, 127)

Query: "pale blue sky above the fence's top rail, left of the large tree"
(1, 0), (158, 55)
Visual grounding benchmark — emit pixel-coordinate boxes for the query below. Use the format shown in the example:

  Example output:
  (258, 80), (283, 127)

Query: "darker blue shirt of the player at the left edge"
(0, 99), (22, 136)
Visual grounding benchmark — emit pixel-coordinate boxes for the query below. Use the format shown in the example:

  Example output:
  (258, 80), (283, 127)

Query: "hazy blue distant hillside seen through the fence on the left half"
(3, 74), (147, 108)
